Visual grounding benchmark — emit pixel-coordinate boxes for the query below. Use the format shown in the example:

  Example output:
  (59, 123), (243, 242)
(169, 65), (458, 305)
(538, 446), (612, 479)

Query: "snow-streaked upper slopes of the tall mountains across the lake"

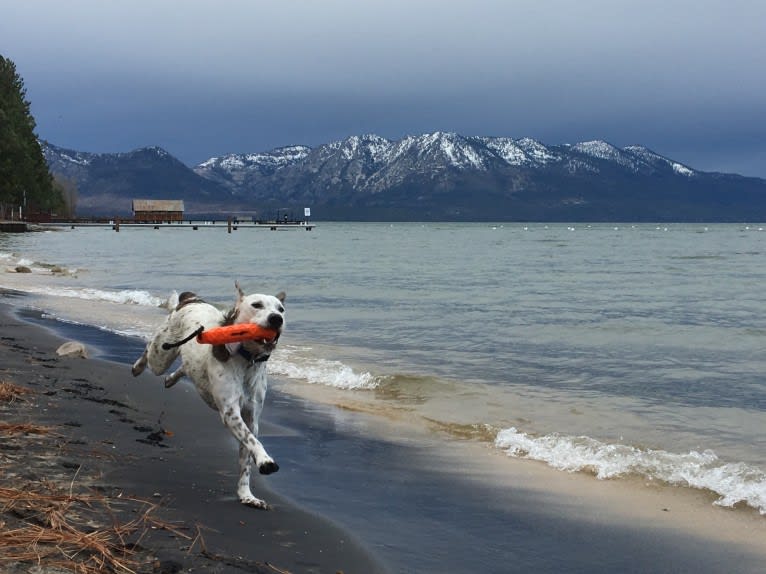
(194, 132), (696, 193)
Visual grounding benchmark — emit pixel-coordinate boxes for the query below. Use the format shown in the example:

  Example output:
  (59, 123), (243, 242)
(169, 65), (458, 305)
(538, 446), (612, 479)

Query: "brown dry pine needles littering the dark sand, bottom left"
(0, 381), (191, 574)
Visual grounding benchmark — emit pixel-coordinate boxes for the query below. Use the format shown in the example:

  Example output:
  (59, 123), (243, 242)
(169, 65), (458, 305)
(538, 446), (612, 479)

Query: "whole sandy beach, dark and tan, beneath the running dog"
(0, 296), (766, 574)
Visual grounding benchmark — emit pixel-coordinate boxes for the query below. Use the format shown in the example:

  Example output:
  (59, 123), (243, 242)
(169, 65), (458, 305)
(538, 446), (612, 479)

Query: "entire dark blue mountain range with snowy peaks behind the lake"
(42, 132), (766, 221)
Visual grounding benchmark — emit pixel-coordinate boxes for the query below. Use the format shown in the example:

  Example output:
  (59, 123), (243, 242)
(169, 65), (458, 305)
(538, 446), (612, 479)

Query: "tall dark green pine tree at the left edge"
(0, 55), (61, 219)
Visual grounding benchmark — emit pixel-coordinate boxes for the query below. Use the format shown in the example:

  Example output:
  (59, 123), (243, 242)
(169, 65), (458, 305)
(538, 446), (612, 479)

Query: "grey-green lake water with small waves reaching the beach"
(0, 223), (766, 514)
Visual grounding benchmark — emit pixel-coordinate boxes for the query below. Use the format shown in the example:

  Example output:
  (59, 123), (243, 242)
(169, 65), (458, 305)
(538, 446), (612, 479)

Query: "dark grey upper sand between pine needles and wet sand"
(0, 302), (386, 573)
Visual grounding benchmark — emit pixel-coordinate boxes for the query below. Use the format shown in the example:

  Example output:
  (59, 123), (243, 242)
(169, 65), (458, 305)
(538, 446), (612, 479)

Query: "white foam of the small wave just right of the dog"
(269, 347), (380, 390)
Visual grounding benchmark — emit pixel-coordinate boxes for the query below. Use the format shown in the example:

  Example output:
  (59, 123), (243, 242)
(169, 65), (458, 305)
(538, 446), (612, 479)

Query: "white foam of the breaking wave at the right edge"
(495, 427), (766, 515)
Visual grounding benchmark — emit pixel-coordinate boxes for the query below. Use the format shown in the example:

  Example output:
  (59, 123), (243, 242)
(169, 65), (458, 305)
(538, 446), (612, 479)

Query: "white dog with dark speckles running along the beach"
(132, 284), (285, 508)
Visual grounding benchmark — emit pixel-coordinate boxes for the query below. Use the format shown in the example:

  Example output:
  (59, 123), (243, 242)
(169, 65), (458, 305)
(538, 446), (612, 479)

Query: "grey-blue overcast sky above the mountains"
(0, 0), (766, 177)
